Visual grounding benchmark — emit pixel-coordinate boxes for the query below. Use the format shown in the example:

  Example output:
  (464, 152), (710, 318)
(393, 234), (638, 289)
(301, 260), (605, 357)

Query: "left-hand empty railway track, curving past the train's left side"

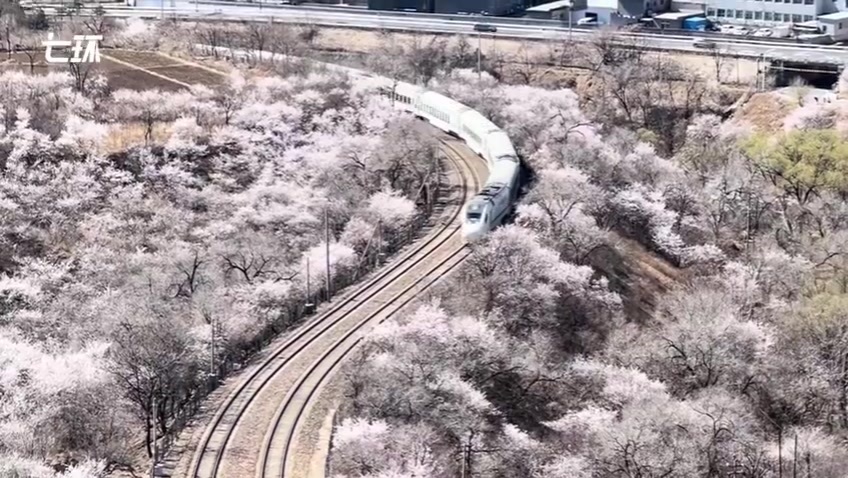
(189, 134), (477, 478)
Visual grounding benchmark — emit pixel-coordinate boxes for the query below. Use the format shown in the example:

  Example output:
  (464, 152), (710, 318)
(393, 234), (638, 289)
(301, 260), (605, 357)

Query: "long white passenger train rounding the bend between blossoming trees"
(372, 80), (520, 241)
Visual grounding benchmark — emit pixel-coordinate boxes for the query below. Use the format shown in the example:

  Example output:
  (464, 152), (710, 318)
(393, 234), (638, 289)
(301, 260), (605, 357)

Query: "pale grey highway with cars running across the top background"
(38, 0), (848, 65)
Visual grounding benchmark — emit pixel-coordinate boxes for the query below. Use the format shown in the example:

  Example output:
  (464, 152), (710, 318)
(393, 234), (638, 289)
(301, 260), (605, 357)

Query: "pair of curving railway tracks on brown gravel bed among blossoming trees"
(188, 139), (481, 478)
